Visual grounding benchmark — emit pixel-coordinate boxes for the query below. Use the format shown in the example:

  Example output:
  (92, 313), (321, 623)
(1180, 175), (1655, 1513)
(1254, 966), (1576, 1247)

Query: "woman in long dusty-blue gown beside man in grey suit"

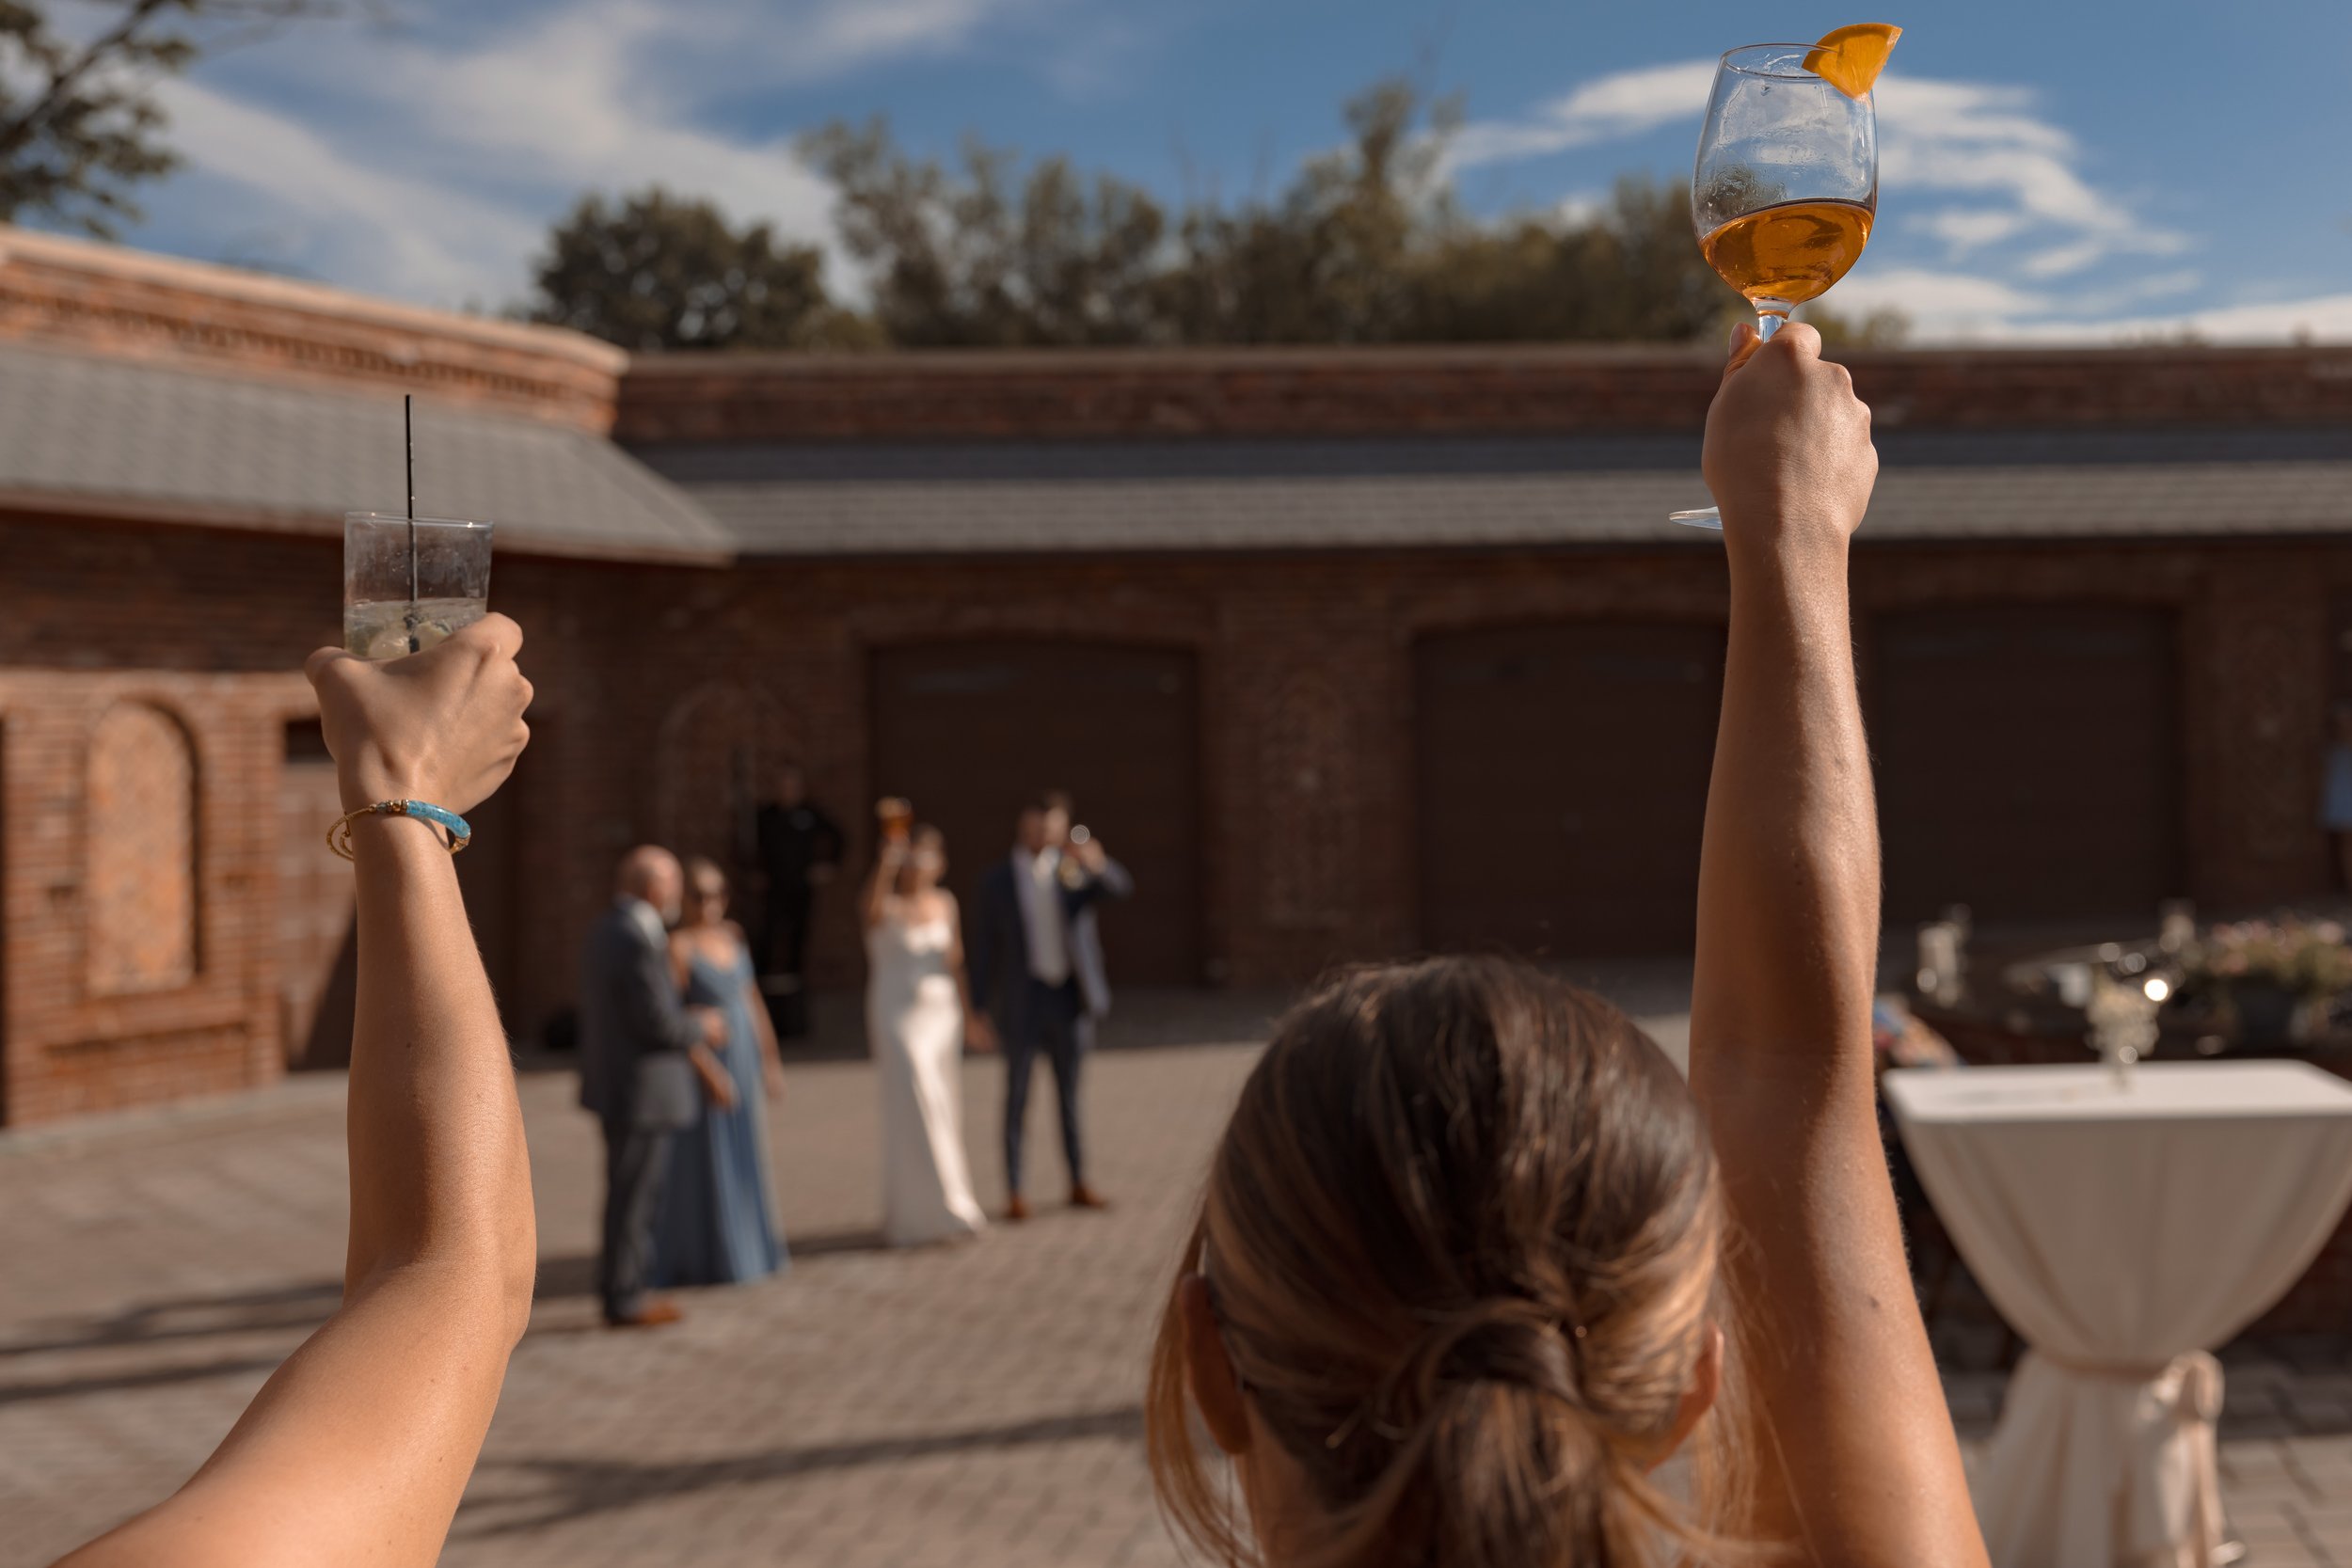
(654, 858), (786, 1286)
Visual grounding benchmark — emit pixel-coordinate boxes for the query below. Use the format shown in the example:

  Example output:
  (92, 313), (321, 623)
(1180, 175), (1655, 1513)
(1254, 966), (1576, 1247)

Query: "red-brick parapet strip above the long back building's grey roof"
(614, 345), (2352, 442)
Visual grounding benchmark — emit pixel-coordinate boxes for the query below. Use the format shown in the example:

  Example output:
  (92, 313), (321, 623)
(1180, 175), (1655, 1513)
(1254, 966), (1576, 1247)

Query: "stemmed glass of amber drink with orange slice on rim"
(1668, 21), (1903, 529)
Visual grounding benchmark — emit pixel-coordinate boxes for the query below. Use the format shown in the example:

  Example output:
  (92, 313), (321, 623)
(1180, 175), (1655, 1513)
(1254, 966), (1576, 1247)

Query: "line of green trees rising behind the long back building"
(536, 82), (1903, 348)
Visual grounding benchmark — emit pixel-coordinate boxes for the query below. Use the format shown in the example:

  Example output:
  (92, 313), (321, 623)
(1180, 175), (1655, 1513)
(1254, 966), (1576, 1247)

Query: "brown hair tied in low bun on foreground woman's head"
(1146, 959), (1739, 1568)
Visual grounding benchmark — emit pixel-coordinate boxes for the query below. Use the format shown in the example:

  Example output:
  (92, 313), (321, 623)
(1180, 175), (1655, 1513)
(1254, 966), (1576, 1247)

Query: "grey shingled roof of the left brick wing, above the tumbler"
(0, 345), (734, 562)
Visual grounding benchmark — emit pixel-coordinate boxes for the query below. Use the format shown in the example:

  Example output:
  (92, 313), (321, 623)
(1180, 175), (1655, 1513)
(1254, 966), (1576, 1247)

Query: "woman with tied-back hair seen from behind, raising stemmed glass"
(1143, 325), (1985, 1568)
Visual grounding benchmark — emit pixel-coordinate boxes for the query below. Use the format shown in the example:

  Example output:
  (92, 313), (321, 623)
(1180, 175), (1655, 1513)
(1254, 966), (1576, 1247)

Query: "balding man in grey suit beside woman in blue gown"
(579, 844), (734, 1328)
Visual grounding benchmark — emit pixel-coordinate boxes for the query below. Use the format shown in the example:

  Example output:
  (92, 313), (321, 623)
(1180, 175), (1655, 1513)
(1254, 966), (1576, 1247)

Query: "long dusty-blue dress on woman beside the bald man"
(654, 947), (788, 1289)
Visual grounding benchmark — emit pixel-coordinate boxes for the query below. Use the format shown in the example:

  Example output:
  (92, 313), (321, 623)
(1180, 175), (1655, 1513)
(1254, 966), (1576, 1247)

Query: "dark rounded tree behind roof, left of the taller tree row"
(527, 185), (875, 350)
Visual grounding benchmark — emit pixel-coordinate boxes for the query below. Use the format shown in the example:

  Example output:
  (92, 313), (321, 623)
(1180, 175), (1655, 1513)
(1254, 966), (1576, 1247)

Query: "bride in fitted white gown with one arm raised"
(866, 828), (991, 1246)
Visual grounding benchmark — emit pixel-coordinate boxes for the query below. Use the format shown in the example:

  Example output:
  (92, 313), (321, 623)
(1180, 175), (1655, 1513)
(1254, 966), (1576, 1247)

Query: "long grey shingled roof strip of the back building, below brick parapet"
(640, 428), (2352, 557)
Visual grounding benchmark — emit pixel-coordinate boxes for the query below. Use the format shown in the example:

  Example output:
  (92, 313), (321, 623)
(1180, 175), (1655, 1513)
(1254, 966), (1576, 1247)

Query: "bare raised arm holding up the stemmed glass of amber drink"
(1692, 325), (1985, 1568)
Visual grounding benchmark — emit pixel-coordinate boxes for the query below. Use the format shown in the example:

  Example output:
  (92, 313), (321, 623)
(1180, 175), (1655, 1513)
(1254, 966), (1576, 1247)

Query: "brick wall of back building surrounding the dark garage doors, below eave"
(527, 533), (2352, 1006)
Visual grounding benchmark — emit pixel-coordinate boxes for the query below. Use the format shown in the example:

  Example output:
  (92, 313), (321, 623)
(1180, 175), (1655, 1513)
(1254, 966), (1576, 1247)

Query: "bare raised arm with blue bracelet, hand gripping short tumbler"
(66, 616), (536, 1568)
